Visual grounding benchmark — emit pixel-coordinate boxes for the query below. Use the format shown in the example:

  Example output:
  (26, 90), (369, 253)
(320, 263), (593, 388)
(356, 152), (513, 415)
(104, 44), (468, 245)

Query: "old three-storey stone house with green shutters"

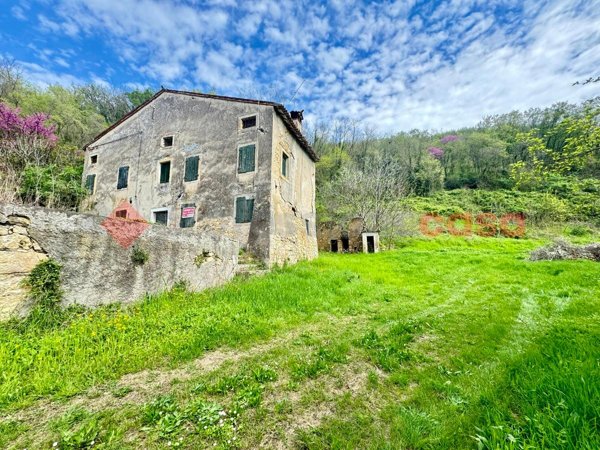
(83, 89), (324, 264)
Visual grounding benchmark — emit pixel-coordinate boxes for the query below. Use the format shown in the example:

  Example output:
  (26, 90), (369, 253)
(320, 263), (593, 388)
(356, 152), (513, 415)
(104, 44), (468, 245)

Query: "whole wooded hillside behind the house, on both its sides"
(0, 61), (600, 238)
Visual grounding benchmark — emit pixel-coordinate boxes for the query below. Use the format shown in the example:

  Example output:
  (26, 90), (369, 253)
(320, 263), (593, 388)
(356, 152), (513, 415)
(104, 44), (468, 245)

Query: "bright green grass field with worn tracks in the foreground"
(0, 238), (600, 449)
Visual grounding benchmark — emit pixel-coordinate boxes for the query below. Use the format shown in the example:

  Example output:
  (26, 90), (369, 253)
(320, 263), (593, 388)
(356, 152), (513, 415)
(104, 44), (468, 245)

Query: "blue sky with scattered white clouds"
(0, 0), (600, 133)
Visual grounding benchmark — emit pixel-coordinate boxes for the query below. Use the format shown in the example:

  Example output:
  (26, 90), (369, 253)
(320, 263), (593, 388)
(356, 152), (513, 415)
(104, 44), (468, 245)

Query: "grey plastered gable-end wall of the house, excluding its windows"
(84, 93), (275, 261)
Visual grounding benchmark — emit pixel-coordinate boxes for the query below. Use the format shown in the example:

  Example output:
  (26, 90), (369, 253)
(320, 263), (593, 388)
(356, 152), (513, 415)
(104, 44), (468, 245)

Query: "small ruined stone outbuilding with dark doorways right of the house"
(317, 217), (379, 253)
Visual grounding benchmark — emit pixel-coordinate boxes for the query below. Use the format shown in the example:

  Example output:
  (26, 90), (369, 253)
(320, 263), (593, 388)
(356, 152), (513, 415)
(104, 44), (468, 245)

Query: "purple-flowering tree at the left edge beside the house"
(0, 102), (58, 201)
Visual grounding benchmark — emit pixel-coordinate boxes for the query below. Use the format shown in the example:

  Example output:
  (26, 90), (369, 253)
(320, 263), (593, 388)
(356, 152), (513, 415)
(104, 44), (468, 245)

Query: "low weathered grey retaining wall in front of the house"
(0, 205), (239, 318)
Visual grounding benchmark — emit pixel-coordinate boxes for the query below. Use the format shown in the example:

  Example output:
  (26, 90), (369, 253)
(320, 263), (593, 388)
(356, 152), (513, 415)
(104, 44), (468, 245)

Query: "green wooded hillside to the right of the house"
(309, 98), (600, 235)
